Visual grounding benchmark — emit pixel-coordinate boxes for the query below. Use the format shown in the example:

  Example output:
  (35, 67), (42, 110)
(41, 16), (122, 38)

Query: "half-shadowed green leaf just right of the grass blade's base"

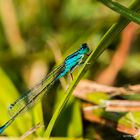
(52, 98), (83, 137)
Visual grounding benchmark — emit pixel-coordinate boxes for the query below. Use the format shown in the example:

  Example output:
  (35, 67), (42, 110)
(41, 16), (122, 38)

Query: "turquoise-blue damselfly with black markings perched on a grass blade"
(0, 43), (89, 134)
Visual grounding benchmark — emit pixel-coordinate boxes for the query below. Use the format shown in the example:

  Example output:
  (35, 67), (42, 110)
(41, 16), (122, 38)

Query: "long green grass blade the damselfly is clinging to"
(44, 1), (140, 138)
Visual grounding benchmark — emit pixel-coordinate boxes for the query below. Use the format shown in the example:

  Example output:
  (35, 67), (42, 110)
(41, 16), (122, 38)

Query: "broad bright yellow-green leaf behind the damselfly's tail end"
(0, 68), (32, 136)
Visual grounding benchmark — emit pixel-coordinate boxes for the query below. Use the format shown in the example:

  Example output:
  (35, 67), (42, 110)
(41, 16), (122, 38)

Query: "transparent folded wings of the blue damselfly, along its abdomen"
(8, 64), (64, 117)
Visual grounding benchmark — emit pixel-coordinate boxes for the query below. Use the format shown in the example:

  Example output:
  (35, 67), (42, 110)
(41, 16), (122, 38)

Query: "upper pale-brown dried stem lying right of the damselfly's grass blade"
(74, 80), (140, 100)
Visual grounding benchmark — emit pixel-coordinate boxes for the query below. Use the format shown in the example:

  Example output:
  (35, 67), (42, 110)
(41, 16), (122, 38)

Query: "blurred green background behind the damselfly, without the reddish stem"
(0, 0), (140, 139)
